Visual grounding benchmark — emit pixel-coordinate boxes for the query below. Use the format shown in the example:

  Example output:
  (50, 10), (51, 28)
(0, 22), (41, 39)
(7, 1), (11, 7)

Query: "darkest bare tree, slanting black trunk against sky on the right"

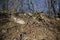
(48, 0), (56, 17)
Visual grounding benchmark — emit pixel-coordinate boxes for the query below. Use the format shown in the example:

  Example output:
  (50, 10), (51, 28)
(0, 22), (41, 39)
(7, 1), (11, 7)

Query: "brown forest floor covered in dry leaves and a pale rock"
(0, 13), (60, 40)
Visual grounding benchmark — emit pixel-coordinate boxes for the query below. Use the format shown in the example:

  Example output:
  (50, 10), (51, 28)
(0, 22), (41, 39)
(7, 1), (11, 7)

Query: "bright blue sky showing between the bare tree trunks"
(0, 0), (58, 11)
